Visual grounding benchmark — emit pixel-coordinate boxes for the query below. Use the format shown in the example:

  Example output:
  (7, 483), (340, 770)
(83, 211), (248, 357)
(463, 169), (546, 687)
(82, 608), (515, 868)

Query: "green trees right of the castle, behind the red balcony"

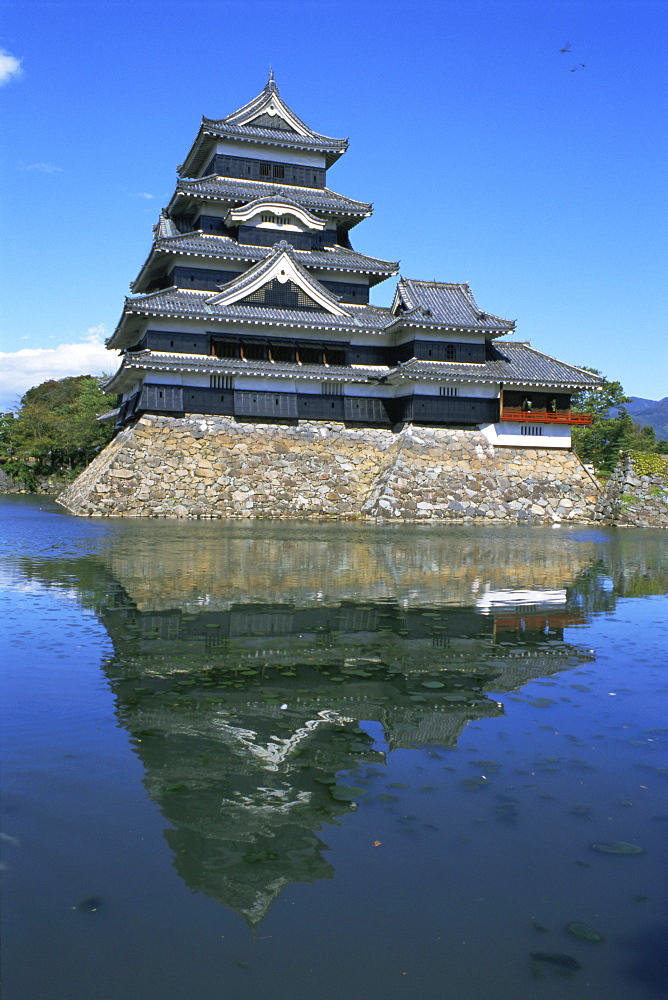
(571, 368), (668, 474)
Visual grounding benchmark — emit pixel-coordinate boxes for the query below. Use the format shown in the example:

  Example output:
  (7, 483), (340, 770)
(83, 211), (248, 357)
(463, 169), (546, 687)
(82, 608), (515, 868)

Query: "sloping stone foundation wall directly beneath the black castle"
(59, 416), (602, 522)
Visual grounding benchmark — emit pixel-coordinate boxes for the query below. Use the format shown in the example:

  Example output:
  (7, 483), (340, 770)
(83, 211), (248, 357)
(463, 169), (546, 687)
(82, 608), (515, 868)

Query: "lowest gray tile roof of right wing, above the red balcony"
(388, 343), (604, 389)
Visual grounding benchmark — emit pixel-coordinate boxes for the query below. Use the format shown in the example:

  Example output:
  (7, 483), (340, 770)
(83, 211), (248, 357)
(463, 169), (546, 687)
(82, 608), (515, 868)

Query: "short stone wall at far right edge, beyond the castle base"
(597, 455), (668, 528)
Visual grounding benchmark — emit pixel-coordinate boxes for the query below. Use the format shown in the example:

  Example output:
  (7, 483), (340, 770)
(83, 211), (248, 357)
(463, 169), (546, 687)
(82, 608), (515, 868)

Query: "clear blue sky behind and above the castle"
(0, 0), (668, 409)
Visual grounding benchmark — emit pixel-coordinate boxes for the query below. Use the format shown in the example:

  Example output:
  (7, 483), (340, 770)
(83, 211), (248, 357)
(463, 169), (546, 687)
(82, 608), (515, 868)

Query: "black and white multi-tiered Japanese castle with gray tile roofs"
(103, 74), (600, 448)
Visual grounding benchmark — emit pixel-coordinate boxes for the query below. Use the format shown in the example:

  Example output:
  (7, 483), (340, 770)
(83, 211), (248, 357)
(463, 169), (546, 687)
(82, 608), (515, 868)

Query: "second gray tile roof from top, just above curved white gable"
(171, 175), (373, 220)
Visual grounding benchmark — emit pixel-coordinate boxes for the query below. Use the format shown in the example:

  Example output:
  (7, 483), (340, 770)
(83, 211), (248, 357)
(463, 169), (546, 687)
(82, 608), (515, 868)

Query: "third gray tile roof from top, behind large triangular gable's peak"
(149, 223), (399, 275)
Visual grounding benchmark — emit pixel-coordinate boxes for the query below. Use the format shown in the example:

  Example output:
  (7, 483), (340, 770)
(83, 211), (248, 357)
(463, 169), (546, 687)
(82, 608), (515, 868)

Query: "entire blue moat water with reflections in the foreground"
(0, 497), (668, 1000)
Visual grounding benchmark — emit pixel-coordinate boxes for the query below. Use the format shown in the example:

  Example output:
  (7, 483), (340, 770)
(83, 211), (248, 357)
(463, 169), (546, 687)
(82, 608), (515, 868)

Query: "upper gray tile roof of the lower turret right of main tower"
(392, 278), (515, 336)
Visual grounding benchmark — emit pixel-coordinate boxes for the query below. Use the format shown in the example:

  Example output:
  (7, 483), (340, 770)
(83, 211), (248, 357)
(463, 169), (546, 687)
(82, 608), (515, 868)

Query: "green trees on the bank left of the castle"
(0, 375), (113, 489)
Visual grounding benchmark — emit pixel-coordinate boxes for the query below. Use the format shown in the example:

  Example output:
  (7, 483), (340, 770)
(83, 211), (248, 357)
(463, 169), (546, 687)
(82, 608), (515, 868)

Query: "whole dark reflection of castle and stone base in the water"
(17, 521), (668, 925)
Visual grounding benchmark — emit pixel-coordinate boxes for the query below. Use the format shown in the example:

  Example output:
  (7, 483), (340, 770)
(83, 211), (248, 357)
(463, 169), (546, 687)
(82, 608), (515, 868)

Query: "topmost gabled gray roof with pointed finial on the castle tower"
(178, 72), (348, 176)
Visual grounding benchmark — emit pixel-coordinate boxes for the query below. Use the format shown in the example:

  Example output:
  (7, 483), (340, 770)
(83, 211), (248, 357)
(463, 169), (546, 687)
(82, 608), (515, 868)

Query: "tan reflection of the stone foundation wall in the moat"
(96, 519), (600, 611)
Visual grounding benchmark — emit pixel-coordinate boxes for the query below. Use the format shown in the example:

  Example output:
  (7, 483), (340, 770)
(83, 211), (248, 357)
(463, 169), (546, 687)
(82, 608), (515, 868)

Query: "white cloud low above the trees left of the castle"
(0, 325), (119, 411)
